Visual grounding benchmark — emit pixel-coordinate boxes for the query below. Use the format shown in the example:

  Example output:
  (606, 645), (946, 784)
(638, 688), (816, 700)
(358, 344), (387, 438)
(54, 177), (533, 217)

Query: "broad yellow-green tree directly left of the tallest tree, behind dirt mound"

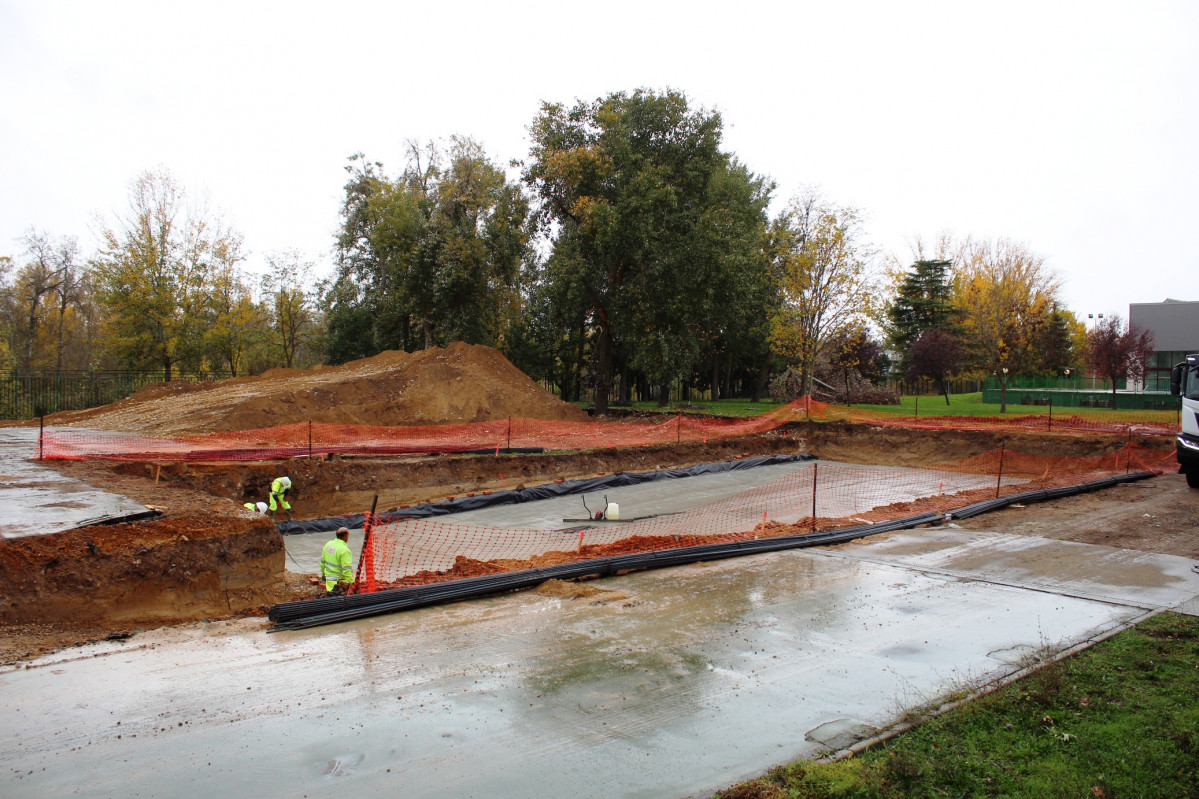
(326, 137), (529, 361)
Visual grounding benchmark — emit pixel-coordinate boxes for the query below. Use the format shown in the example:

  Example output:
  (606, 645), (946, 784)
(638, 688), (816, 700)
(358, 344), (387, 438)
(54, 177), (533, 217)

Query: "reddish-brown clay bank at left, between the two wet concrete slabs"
(0, 501), (313, 662)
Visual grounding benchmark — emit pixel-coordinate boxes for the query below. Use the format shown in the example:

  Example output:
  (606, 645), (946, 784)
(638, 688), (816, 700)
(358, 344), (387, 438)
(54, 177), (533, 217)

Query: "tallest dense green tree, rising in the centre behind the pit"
(524, 89), (770, 414)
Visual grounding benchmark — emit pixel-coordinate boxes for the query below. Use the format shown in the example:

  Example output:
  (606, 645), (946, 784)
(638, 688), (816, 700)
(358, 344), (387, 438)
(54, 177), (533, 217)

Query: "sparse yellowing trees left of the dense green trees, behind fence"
(0, 170), (324, 380)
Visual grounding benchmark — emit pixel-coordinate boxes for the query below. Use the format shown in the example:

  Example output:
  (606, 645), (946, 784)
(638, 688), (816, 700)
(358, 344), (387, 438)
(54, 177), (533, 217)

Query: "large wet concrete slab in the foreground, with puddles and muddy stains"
(0, 530), (1160, 798)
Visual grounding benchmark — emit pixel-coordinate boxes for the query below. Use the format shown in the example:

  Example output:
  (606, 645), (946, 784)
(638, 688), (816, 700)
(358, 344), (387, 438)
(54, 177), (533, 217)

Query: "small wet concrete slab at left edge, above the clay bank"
(0, 427), (149, 537)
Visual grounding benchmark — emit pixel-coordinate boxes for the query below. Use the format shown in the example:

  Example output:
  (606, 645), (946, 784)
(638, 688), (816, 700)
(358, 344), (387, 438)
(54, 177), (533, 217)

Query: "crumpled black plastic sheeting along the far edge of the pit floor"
(276, 452), (815, 535)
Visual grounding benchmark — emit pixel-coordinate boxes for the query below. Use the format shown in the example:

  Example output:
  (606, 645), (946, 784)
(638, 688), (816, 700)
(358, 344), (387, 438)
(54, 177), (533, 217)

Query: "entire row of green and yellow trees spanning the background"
(0, 90), (1152, 413)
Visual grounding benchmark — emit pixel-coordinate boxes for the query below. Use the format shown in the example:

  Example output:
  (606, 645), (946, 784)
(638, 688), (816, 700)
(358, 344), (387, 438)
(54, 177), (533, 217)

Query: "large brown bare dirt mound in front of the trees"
(46, 342), (586, 435)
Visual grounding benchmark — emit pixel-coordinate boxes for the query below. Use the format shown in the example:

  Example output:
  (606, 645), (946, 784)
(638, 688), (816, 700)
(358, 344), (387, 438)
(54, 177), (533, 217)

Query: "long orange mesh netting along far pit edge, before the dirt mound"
(40, 397), (1179, 461)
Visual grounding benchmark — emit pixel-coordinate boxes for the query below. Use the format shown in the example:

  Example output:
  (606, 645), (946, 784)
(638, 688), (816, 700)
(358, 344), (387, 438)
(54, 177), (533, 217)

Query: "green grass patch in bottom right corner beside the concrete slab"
(717, 613), (1199, 799)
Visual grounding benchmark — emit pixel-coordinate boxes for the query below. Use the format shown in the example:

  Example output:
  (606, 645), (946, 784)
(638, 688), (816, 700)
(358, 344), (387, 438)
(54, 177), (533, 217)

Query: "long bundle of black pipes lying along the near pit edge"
(266, 471), (1157, 632)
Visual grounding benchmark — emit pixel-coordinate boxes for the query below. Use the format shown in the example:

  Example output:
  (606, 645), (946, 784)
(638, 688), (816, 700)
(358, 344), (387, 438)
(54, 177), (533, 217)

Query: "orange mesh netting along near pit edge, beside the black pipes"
(356, 445), (1177, 593)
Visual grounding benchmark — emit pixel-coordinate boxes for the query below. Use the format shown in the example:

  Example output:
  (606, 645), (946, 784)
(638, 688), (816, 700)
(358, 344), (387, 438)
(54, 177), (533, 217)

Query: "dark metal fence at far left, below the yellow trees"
(0, 370), (229, 419)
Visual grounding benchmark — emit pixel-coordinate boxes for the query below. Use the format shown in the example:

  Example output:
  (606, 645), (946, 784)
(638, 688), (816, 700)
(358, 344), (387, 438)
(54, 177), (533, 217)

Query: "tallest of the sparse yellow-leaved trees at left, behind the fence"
(95, 170), (242, 380)
